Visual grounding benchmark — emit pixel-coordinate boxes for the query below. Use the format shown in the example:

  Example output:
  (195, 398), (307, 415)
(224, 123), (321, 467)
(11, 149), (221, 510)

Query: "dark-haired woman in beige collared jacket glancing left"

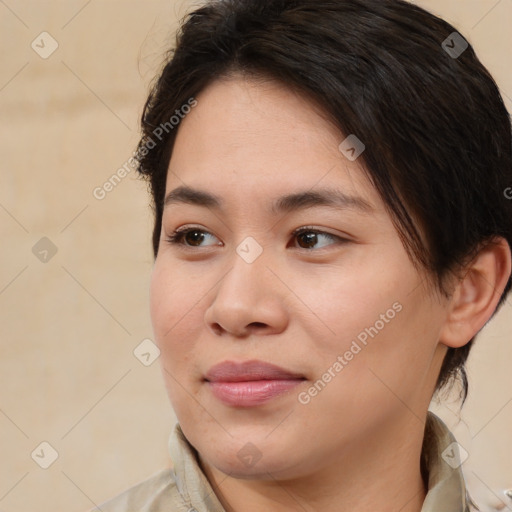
(94, 0), (512, 512)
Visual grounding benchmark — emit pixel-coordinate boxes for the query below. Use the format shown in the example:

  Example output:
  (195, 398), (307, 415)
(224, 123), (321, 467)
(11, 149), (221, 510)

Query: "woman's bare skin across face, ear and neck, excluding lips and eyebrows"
(151, 76), (510, 512)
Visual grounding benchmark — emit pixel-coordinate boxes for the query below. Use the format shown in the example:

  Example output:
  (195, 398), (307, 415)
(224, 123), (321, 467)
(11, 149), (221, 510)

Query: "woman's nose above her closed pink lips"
(204, 250), (288, 338)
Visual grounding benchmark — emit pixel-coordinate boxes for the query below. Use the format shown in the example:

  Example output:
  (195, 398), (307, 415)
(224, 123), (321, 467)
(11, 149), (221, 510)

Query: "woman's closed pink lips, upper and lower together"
(205, 360), (305, 407)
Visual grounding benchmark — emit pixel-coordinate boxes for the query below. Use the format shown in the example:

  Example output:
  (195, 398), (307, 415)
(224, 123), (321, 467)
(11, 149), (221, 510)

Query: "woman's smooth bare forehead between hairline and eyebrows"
(166, 77), (380, 210)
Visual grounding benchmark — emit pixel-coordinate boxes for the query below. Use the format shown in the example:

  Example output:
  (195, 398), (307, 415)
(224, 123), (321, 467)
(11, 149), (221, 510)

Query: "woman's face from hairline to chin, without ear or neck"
(151, 78), (446, 478)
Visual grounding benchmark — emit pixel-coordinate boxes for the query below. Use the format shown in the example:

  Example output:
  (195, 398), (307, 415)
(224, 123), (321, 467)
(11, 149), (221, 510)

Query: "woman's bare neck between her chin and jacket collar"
(201, 418), (426, 512)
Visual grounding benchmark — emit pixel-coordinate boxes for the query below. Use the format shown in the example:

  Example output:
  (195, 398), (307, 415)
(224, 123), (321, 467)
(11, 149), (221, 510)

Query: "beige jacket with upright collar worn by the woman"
(91, 412), (470, 512)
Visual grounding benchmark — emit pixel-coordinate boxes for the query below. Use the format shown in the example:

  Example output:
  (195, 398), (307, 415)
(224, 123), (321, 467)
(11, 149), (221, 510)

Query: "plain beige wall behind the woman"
(0, 0), (512, 512)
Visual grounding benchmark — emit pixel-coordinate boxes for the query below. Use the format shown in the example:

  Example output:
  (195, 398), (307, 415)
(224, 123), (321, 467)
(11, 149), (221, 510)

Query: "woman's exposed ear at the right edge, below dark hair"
(439, 237), (511, 348)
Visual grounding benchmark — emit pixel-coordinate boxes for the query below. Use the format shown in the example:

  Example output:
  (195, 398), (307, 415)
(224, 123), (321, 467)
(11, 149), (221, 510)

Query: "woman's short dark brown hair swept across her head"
(137, 0), (512, 404)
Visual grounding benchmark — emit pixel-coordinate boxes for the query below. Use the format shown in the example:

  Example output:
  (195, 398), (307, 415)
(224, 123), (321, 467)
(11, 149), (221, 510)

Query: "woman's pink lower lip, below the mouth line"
(208, 379), (303, 407)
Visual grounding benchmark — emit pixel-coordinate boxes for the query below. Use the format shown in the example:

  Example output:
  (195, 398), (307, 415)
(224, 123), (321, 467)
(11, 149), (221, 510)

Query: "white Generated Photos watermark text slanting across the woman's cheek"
(297, 302), (403, 405)
